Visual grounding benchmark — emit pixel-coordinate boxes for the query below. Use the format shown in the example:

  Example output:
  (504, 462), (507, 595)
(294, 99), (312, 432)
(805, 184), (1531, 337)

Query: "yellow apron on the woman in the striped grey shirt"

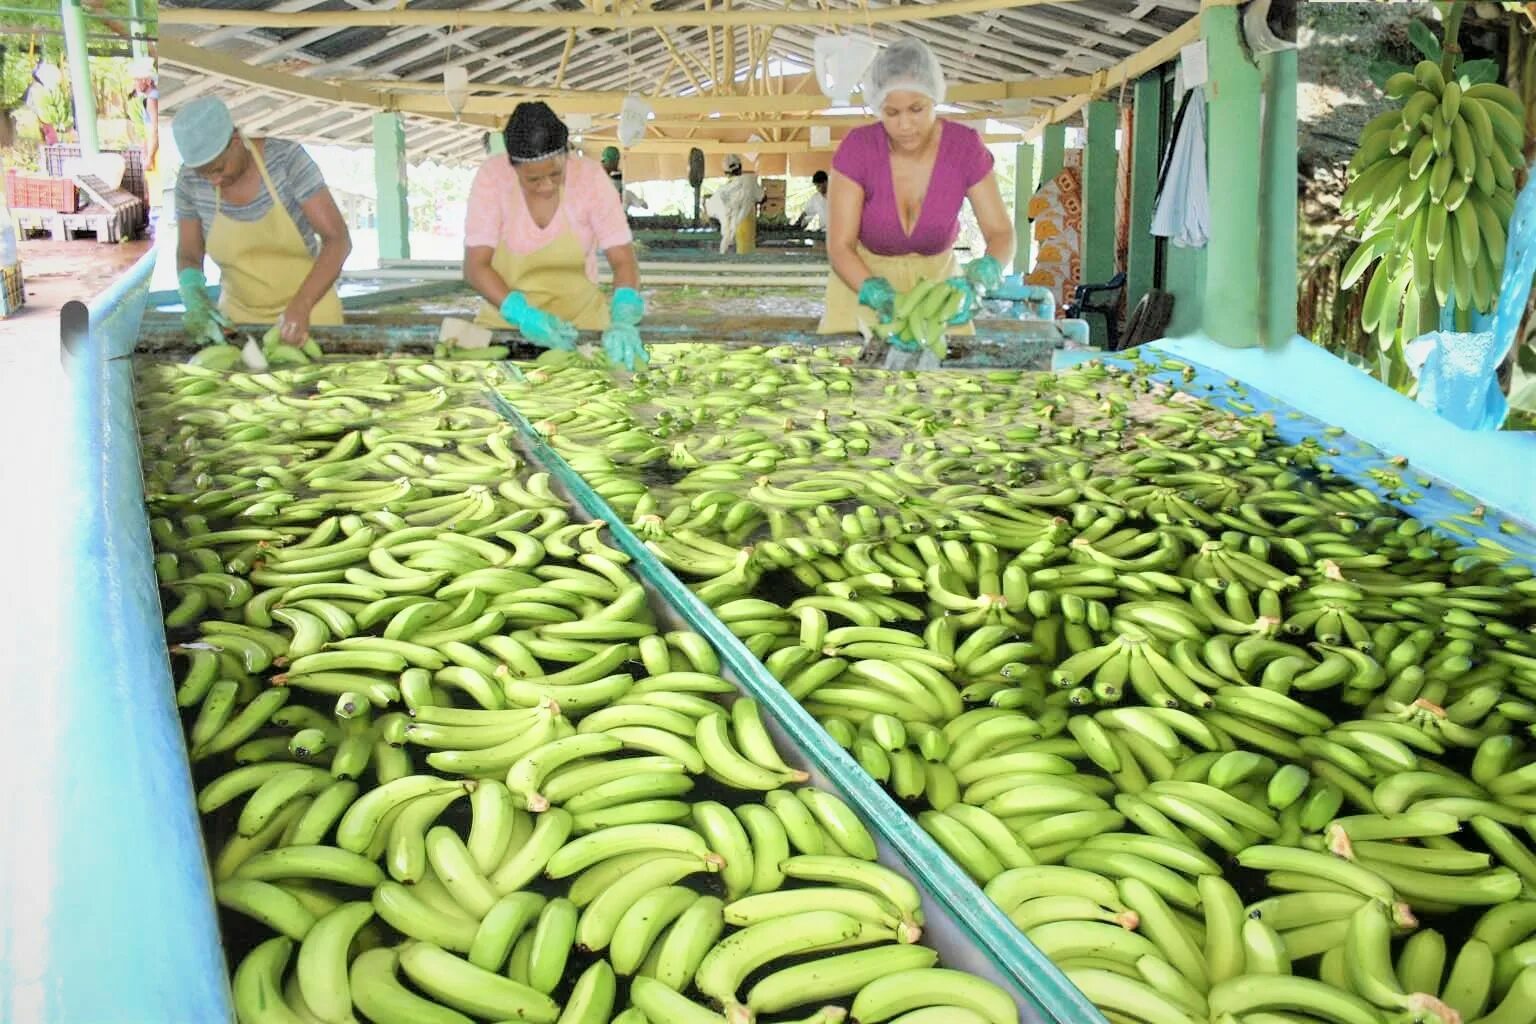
(206, 140), (341, 327)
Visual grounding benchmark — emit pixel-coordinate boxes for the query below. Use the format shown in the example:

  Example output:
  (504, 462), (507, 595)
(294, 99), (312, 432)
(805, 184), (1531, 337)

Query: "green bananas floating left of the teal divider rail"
(143, 361), (1017, 1024)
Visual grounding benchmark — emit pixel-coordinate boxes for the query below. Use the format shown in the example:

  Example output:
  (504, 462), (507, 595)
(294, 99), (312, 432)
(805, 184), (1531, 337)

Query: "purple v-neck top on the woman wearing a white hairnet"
(833, 118), (992, 256)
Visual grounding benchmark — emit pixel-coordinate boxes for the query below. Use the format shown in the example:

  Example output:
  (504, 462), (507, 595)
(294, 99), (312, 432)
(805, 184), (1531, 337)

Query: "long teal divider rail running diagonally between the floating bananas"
(488, 379), (1104, 1024)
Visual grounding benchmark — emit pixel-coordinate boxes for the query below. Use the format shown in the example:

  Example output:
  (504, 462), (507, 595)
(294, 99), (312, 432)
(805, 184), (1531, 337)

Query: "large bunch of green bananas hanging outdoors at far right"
(1339, 60), (1525, 348)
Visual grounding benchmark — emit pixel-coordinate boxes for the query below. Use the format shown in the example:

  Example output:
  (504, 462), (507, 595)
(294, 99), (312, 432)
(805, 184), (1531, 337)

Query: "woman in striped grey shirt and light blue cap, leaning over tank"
(170, 97), (352, 345)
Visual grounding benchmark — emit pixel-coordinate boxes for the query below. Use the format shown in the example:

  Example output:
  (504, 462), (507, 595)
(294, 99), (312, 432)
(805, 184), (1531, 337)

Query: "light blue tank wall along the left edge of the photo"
(0, 255), (233, 1024)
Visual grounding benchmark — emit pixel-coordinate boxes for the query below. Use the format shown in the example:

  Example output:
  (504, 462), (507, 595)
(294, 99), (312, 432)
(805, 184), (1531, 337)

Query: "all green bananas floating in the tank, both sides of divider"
(141, 343), (1536, 1022)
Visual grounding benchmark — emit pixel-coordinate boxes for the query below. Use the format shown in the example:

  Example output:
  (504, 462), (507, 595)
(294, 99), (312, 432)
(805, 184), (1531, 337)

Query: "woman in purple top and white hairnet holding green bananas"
(820, 38), (1014, 365)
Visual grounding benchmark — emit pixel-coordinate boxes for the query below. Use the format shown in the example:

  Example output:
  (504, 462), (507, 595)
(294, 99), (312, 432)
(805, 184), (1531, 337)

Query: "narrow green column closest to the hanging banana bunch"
(1260, 49), (1296, 345)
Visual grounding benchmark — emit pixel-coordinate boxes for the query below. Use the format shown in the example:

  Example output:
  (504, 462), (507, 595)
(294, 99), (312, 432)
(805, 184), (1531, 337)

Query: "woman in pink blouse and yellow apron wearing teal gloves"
(464, 103), (650, 370)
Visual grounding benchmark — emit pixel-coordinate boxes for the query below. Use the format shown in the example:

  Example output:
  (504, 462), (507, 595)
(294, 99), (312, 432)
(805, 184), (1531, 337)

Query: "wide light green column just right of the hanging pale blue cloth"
(1200, 6), (1259, 348)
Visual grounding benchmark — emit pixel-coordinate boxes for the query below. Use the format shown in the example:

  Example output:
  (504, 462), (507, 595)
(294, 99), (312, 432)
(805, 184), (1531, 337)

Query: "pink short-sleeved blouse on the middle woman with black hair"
(464, 154), (634, 281)
